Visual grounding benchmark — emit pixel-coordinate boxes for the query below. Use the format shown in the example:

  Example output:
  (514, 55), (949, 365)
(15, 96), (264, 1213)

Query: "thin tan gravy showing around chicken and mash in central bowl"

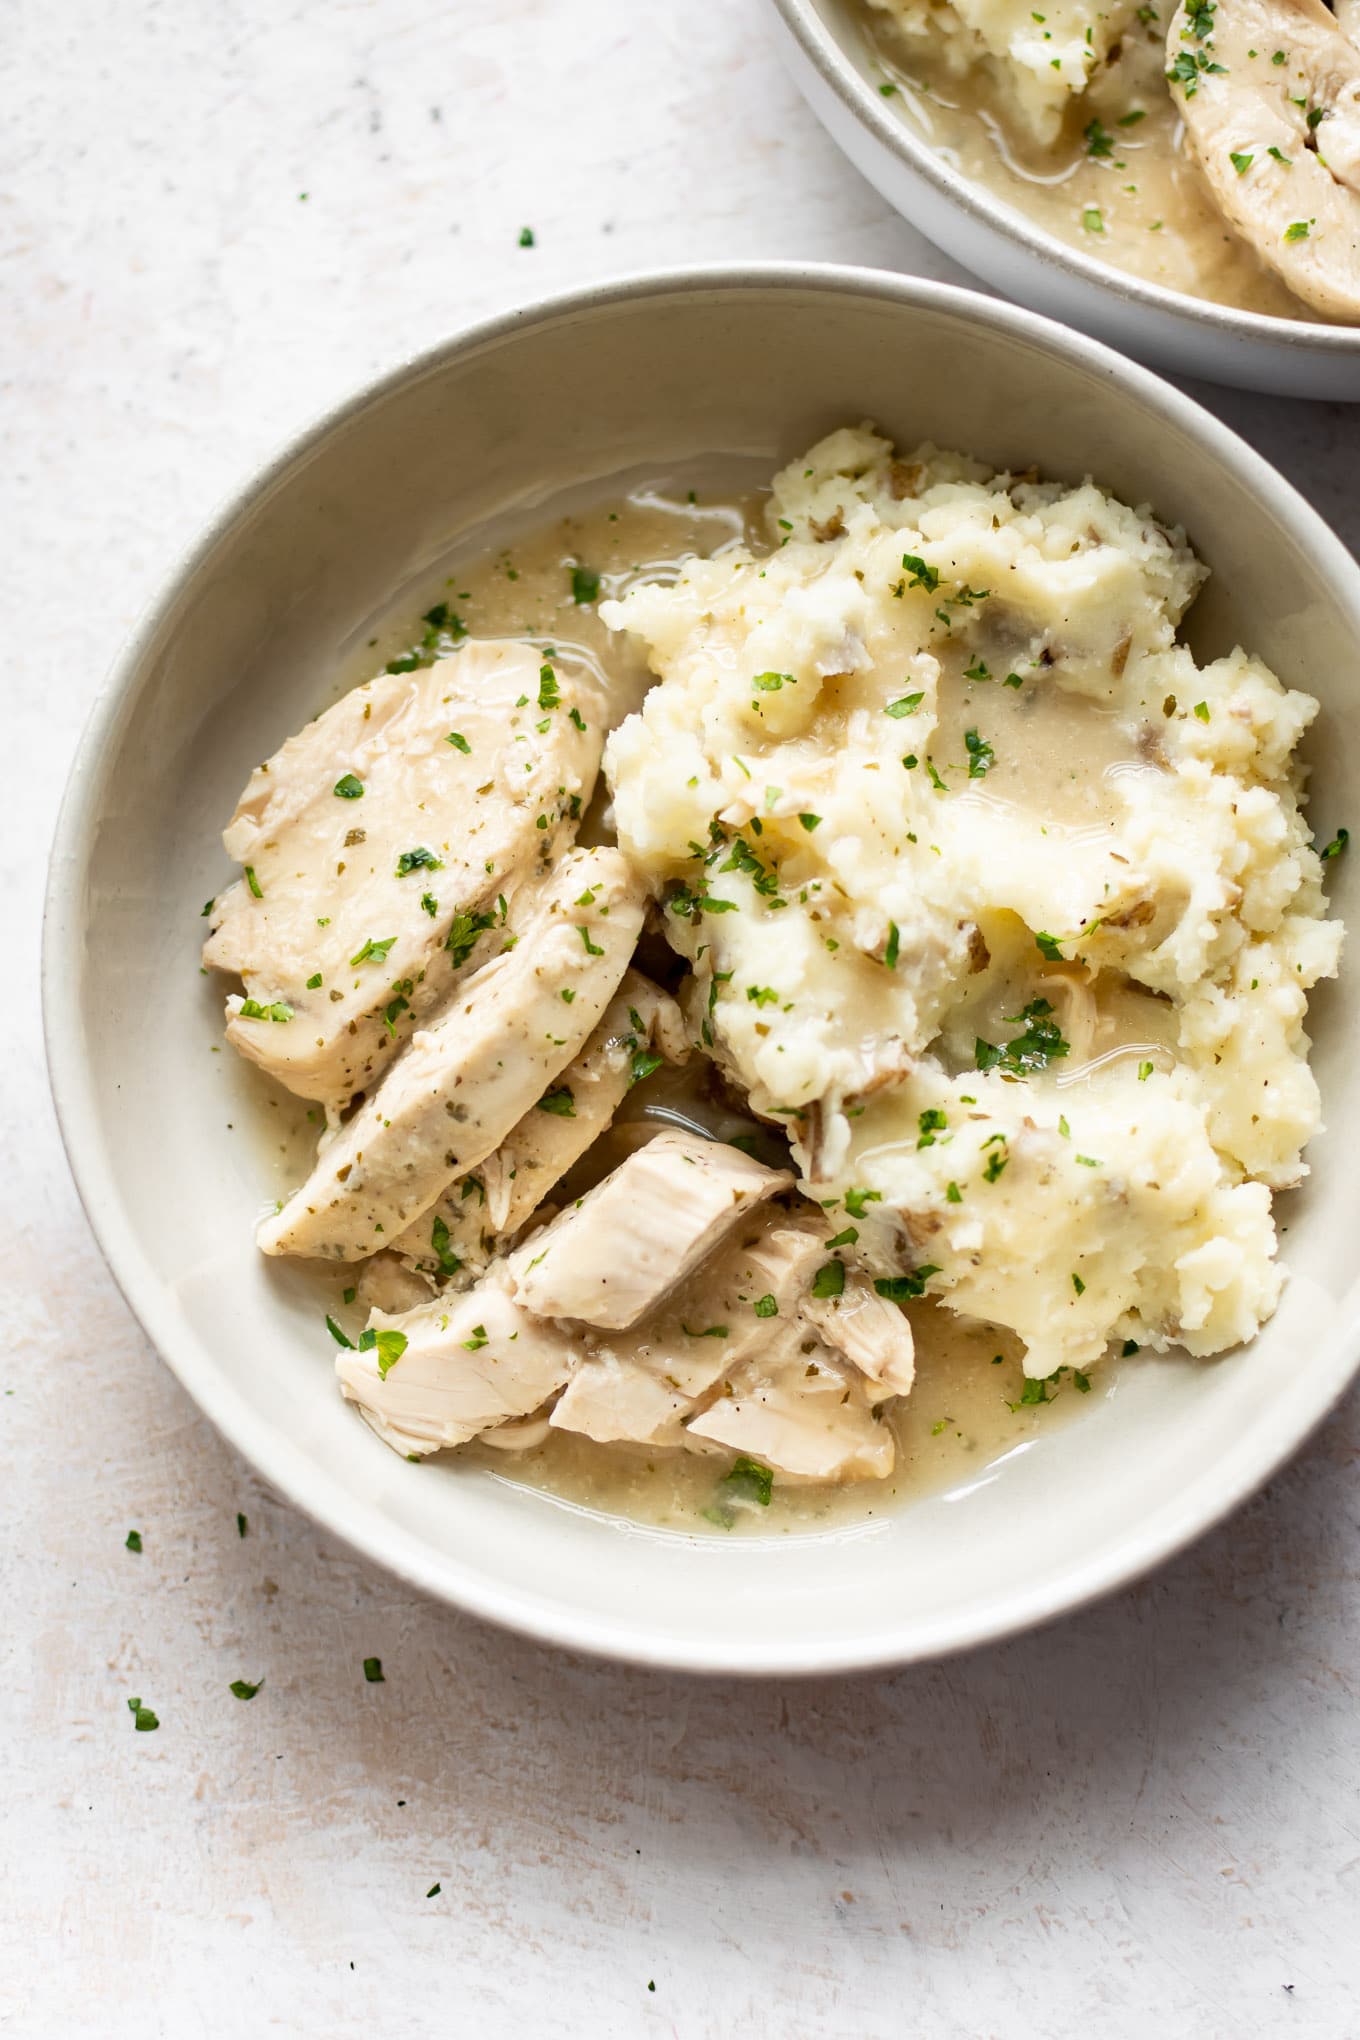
(243, 483), (1125, 1538)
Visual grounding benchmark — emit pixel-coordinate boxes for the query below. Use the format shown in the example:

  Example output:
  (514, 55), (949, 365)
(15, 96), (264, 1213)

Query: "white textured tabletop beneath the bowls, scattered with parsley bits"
(0, 0), (1360, 2040)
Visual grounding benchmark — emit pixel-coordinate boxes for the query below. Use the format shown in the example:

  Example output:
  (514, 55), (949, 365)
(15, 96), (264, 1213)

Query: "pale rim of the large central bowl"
(41, 261), (1360, 1677)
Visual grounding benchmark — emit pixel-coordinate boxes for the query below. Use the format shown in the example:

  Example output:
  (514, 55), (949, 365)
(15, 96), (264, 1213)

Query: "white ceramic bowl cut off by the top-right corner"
(769, 0), (1360, 402)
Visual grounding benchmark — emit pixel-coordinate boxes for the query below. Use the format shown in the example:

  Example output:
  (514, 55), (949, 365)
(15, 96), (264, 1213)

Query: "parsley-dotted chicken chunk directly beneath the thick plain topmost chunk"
(551, 1208), (826, 1444)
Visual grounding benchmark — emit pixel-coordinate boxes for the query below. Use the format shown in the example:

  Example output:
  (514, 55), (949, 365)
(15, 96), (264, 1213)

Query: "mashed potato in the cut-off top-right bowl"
(869, 0), (1138, 143)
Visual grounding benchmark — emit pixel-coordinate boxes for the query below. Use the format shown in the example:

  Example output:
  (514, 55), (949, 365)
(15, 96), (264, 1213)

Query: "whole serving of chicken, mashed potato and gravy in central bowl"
(206, 428), (1340, 1532)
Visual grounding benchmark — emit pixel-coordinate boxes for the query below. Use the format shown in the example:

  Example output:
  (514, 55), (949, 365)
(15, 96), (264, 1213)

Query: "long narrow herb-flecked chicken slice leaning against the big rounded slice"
(257, 849), (644, 1261)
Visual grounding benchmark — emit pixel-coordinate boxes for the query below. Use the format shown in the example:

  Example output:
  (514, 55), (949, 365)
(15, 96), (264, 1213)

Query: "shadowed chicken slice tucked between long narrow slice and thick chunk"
(394, 971), (689, 1275)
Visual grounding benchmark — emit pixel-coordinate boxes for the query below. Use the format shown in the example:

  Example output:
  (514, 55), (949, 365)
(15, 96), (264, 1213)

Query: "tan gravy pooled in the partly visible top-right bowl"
(860, 6), (1317, 318)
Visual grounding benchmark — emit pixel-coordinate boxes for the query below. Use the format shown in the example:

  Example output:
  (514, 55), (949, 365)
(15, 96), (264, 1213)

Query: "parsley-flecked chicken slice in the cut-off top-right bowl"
(1166, 0), (1360, 320)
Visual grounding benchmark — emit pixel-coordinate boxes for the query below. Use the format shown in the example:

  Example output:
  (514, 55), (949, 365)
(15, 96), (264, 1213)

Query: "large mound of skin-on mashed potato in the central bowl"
(601, 426), (1340, 1377)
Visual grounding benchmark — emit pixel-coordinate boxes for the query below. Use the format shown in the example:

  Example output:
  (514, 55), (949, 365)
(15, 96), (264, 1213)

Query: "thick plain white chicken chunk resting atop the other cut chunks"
(506, 1128), (793, 1330)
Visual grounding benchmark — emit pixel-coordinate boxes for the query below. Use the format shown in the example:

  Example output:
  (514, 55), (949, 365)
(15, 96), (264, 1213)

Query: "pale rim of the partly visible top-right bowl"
(769, 0), (1360, 359)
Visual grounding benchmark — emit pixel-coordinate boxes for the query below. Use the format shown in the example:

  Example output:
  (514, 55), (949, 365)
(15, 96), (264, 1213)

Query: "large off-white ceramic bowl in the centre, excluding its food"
(43, 267), (1360, 1673)
